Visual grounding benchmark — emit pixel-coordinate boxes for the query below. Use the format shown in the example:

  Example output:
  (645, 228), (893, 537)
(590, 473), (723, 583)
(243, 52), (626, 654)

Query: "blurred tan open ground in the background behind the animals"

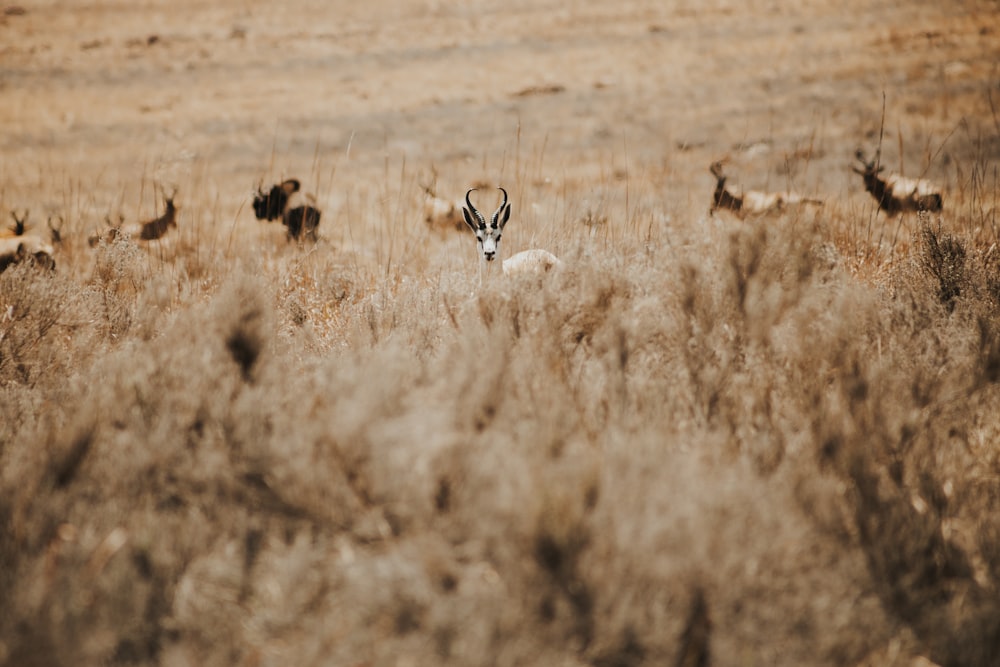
(0, 0), (1000, 250)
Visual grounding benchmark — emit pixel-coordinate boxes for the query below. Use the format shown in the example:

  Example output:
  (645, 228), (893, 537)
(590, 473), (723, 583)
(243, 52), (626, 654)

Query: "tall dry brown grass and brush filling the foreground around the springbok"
(0, 144), (1000, 667)
